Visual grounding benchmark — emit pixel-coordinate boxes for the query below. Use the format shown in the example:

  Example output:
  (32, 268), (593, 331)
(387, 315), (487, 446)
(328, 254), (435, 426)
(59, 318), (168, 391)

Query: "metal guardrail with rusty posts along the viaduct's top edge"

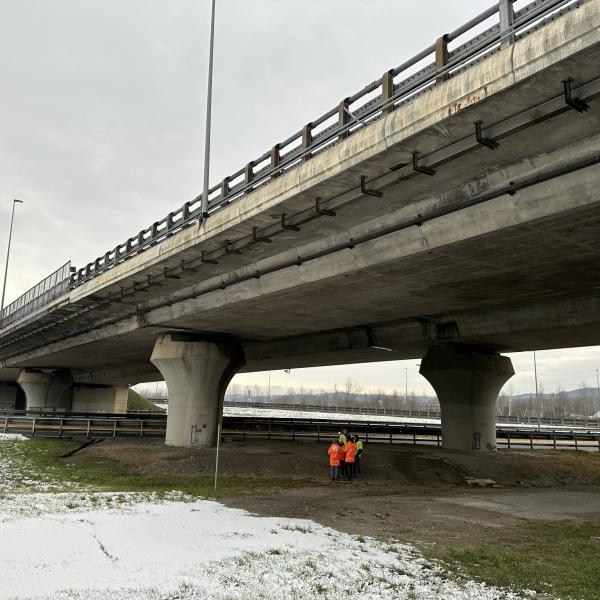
(0, 0), (585, 327)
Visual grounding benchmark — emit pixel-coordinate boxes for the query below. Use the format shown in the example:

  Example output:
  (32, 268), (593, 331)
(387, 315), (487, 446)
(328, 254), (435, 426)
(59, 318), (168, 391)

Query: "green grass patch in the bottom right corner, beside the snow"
(425, 520), (600, 600)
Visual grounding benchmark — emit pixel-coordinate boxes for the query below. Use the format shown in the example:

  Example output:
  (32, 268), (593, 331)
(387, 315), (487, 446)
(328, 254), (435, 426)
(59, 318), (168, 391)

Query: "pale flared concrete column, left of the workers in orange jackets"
(150, 334), (244, 448)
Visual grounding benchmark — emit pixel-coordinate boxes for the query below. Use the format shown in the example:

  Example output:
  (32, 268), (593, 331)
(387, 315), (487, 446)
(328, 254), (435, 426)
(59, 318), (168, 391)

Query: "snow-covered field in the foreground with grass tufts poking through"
(0, 436), (527, 600)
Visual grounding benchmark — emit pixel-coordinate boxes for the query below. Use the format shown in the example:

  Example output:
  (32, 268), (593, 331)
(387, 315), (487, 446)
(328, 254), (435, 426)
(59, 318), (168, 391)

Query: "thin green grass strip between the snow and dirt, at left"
(19, 440), (306, 498)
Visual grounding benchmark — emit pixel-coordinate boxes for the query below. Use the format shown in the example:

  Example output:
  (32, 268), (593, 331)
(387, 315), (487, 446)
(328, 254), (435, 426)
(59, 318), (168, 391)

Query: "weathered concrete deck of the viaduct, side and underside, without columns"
(0, 0), (600, 436)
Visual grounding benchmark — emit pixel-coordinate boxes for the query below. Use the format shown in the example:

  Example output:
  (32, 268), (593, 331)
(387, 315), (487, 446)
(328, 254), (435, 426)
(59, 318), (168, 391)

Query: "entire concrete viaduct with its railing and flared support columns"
(0, 0), (600, 450)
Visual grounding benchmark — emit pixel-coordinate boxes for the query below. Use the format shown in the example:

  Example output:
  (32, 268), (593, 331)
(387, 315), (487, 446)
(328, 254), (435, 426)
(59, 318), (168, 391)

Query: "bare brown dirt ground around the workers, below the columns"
(75, 439), (600, 549)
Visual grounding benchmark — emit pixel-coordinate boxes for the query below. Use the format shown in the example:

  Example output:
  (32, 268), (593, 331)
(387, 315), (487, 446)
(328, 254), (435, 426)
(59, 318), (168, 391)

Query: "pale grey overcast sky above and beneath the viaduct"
(0, 0), (600, 391)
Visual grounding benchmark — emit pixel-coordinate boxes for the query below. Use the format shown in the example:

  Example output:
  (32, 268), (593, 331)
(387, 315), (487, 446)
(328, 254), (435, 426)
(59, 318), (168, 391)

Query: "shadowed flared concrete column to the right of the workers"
(420, 345), (515, 450)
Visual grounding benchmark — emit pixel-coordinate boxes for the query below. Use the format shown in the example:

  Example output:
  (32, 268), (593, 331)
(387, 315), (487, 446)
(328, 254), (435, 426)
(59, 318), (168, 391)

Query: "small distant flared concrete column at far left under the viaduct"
(17, 370), (73, 412)
